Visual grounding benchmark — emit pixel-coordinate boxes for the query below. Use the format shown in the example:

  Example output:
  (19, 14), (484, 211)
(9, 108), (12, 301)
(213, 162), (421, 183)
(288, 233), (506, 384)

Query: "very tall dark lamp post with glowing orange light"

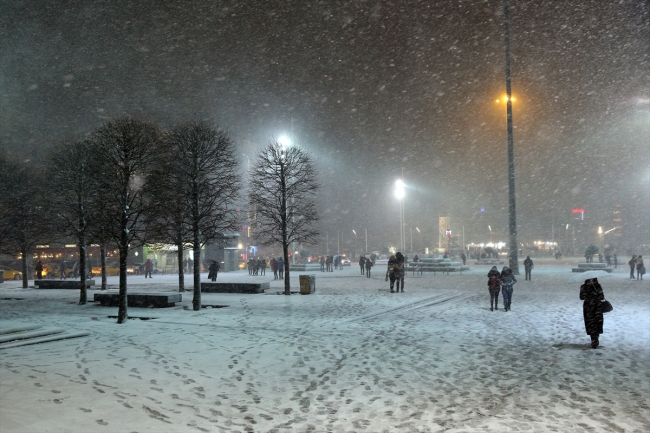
(503, 0), (519, 275)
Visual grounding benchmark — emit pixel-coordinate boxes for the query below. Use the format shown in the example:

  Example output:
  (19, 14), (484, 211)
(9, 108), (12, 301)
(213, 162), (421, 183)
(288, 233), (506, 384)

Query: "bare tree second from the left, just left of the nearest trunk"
(48, 141), (97, 305)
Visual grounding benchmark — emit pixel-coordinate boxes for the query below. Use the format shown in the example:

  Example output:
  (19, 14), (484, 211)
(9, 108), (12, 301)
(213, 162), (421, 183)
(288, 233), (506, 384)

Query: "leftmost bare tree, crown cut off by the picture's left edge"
(0, 156), (51, 289)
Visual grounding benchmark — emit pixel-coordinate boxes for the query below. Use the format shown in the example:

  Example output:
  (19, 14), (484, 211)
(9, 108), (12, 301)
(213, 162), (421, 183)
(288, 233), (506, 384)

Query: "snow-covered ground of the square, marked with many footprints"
(0, 258), (650, 433)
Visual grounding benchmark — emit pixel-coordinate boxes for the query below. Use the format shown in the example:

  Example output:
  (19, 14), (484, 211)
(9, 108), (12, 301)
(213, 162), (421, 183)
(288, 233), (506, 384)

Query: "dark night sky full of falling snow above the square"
(0, 0), (650, 248)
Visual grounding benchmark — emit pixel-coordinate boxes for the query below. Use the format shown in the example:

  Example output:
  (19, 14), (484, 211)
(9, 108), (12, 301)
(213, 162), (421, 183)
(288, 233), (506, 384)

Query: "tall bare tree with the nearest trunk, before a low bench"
(90, 118), (160, 323)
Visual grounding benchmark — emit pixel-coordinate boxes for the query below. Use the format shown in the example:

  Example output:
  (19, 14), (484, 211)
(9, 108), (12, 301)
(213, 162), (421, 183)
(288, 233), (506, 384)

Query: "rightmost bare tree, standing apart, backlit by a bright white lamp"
(248, 141), (320, 295)
